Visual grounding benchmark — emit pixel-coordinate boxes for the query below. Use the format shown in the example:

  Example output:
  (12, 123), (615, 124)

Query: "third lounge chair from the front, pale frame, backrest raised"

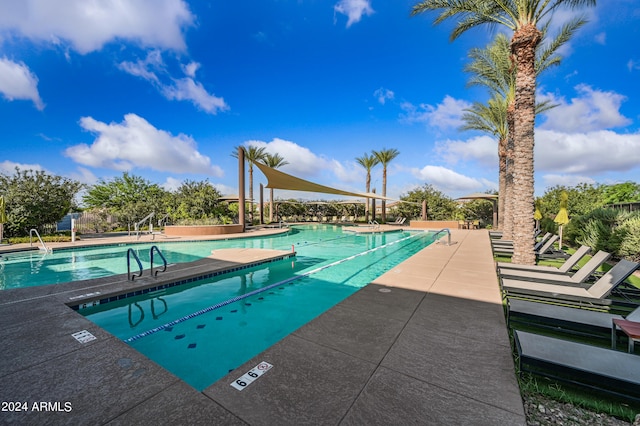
(502, 259), (640, 304)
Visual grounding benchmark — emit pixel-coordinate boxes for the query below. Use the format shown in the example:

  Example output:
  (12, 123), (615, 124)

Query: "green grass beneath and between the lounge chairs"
(495, 247), (640, 422)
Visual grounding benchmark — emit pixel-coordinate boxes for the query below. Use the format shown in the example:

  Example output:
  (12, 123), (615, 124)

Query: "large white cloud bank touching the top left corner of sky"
(0, 0), (195, 54)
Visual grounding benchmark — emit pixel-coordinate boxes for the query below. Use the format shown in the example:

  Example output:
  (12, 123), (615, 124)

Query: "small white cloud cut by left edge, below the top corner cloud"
(0, 57), (44, 111)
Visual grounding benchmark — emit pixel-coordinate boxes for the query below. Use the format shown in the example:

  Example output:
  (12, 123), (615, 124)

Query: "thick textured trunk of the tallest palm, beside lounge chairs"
(511, 24), (541, 265)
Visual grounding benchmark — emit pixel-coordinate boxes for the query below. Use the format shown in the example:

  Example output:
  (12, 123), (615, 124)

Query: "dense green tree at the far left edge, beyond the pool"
(0, 167), (84, 237)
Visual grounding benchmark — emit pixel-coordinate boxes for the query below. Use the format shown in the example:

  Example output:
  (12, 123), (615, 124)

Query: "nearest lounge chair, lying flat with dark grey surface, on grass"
(513, 330), (640, 401)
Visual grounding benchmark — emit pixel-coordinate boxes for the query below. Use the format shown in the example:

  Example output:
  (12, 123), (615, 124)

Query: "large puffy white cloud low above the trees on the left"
(65, 114), (223, 176)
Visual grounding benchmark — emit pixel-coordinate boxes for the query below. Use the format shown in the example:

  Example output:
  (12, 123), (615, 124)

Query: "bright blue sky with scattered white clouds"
(0, 0), (640, 203)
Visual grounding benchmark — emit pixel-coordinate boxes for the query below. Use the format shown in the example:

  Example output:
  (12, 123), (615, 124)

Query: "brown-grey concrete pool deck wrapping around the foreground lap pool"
(0, 230), (526, 425)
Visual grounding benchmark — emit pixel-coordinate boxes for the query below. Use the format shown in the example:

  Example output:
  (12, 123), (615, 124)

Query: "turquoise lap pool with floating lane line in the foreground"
(80, 227), (433, 390)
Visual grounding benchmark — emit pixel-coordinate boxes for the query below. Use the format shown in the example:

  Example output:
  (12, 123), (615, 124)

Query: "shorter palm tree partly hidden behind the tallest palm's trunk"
(462, 28), (584, 235)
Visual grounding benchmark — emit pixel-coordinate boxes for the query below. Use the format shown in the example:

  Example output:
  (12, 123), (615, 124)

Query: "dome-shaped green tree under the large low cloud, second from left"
(83, 172), (167, 230)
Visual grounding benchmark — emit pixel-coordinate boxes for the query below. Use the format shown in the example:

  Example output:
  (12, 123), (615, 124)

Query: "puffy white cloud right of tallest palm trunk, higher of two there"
(539, 84), (631, 133)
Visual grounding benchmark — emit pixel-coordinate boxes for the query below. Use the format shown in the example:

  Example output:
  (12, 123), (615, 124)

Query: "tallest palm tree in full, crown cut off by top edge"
(411, 0), (596, 264)
